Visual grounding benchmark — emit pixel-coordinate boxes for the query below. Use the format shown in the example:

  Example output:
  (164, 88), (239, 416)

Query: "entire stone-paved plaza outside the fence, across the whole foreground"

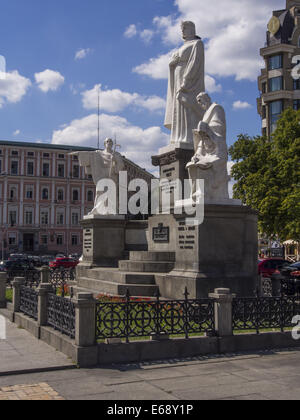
(0, 323), (300, 401)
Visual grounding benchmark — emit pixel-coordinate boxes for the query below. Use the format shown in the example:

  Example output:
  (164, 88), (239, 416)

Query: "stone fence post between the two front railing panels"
(209, 289), (235, 337)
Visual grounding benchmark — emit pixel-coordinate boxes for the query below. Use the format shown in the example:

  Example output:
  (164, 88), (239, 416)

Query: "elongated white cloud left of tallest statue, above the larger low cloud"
(82, 85), (166, 113)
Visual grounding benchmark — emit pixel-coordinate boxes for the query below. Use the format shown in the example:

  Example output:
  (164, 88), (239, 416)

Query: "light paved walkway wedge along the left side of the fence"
(0, 320), (75, 376)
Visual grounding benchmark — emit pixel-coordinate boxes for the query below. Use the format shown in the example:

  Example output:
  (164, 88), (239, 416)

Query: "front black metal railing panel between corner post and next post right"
(96, 291), (215, 342)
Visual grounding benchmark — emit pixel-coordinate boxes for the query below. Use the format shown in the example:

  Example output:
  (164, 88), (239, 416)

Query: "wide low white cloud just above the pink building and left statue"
(52, 114), (169, 171)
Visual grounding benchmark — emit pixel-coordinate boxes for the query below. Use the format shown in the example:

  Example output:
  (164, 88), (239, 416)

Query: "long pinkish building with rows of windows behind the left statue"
(0, 141), (154, 257)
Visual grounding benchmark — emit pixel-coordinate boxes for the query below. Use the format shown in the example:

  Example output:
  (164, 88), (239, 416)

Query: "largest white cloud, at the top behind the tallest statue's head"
(135, 0), (283, 81)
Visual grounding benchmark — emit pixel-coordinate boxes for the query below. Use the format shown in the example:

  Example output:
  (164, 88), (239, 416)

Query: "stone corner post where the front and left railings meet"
(74, 293), (96, 347)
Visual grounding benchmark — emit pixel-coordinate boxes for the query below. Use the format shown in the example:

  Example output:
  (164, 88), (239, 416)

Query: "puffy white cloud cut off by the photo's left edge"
(0, 70), (31, 108)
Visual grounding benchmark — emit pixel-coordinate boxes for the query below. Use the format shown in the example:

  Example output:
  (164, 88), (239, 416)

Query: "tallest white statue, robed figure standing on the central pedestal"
(165, 22), (205, 147)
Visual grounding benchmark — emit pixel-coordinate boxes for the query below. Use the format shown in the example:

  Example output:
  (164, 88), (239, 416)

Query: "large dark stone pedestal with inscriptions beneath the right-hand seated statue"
(149, 205), (258, 299)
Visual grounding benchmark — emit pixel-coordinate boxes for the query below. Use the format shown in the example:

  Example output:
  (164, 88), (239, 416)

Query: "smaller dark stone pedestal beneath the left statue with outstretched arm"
(81, 216), (126, 267)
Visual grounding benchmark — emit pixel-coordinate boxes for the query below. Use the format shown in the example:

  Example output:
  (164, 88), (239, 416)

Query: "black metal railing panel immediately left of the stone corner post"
(47, 293), (75, 339)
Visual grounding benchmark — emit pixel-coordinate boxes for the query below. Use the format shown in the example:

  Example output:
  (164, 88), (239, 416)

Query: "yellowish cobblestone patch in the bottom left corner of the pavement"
(0, 383), (64, 401)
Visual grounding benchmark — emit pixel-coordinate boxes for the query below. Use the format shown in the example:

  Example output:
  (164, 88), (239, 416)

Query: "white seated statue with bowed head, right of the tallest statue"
(186, 92), (230, 202)
